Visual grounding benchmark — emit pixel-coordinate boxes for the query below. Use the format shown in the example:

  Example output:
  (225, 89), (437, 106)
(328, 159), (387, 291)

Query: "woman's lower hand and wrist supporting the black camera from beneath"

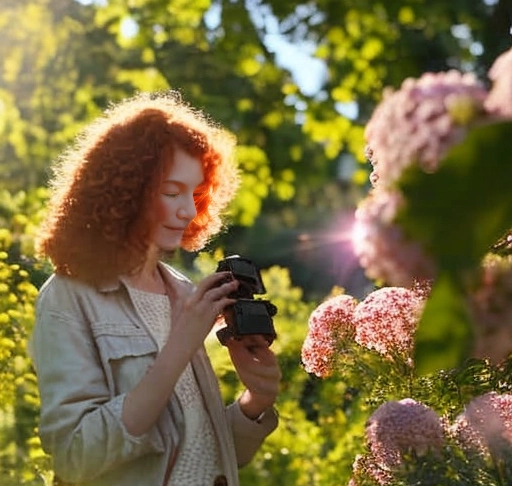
(226, 335), (281, 419)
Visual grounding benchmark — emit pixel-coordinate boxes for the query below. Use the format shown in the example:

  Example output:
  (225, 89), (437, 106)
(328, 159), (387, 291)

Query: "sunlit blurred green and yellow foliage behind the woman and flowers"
(0, 0), (511, 486)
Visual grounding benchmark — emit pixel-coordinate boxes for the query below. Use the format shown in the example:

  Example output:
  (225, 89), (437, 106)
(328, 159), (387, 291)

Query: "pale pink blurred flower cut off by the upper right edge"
(485, 48), (512, 118)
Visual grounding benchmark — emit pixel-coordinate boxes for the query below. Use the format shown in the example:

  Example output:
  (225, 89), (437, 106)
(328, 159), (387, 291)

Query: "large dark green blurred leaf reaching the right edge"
(397, 122), (512, 274)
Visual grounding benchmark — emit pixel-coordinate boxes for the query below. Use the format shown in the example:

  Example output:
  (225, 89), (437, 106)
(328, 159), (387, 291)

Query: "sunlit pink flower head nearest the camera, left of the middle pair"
(301, 294), (358, 378)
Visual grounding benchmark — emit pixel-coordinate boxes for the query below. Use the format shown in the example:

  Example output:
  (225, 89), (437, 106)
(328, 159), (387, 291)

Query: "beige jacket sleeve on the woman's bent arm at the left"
(32, 286), (164, 482)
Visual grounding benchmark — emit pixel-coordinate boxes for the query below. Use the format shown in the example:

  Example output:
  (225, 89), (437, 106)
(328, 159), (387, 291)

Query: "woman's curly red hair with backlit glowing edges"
(38, 92), (239, 283)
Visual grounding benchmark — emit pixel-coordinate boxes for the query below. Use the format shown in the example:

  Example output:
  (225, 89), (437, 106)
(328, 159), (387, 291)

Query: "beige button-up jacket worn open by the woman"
(32, 265), (277, 486)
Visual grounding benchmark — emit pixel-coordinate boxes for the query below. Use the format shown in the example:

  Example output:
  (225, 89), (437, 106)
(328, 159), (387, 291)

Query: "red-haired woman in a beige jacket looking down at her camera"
(33, 93), (280, 486)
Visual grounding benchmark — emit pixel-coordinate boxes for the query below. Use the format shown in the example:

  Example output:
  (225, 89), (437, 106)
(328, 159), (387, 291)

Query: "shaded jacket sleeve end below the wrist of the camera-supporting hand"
(226, 402), (278, 467)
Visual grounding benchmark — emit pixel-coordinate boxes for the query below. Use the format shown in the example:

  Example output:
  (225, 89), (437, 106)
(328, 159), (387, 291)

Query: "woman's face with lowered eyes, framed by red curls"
(153, 149), (204, 251)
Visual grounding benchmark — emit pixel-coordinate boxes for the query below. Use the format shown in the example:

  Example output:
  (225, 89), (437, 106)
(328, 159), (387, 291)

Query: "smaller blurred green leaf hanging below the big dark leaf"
(414, 273), (473, 375)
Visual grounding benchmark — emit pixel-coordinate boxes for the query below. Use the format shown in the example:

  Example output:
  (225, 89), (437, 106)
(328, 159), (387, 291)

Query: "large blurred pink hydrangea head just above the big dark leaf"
(365, 70), (487, 187)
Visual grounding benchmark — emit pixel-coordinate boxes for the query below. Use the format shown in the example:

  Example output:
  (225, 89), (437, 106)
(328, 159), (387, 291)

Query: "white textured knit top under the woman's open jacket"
(129, 287), (221, 486)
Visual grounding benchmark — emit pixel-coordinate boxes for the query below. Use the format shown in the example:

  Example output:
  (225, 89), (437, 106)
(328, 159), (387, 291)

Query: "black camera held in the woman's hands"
(216, 255), (277, 346)
